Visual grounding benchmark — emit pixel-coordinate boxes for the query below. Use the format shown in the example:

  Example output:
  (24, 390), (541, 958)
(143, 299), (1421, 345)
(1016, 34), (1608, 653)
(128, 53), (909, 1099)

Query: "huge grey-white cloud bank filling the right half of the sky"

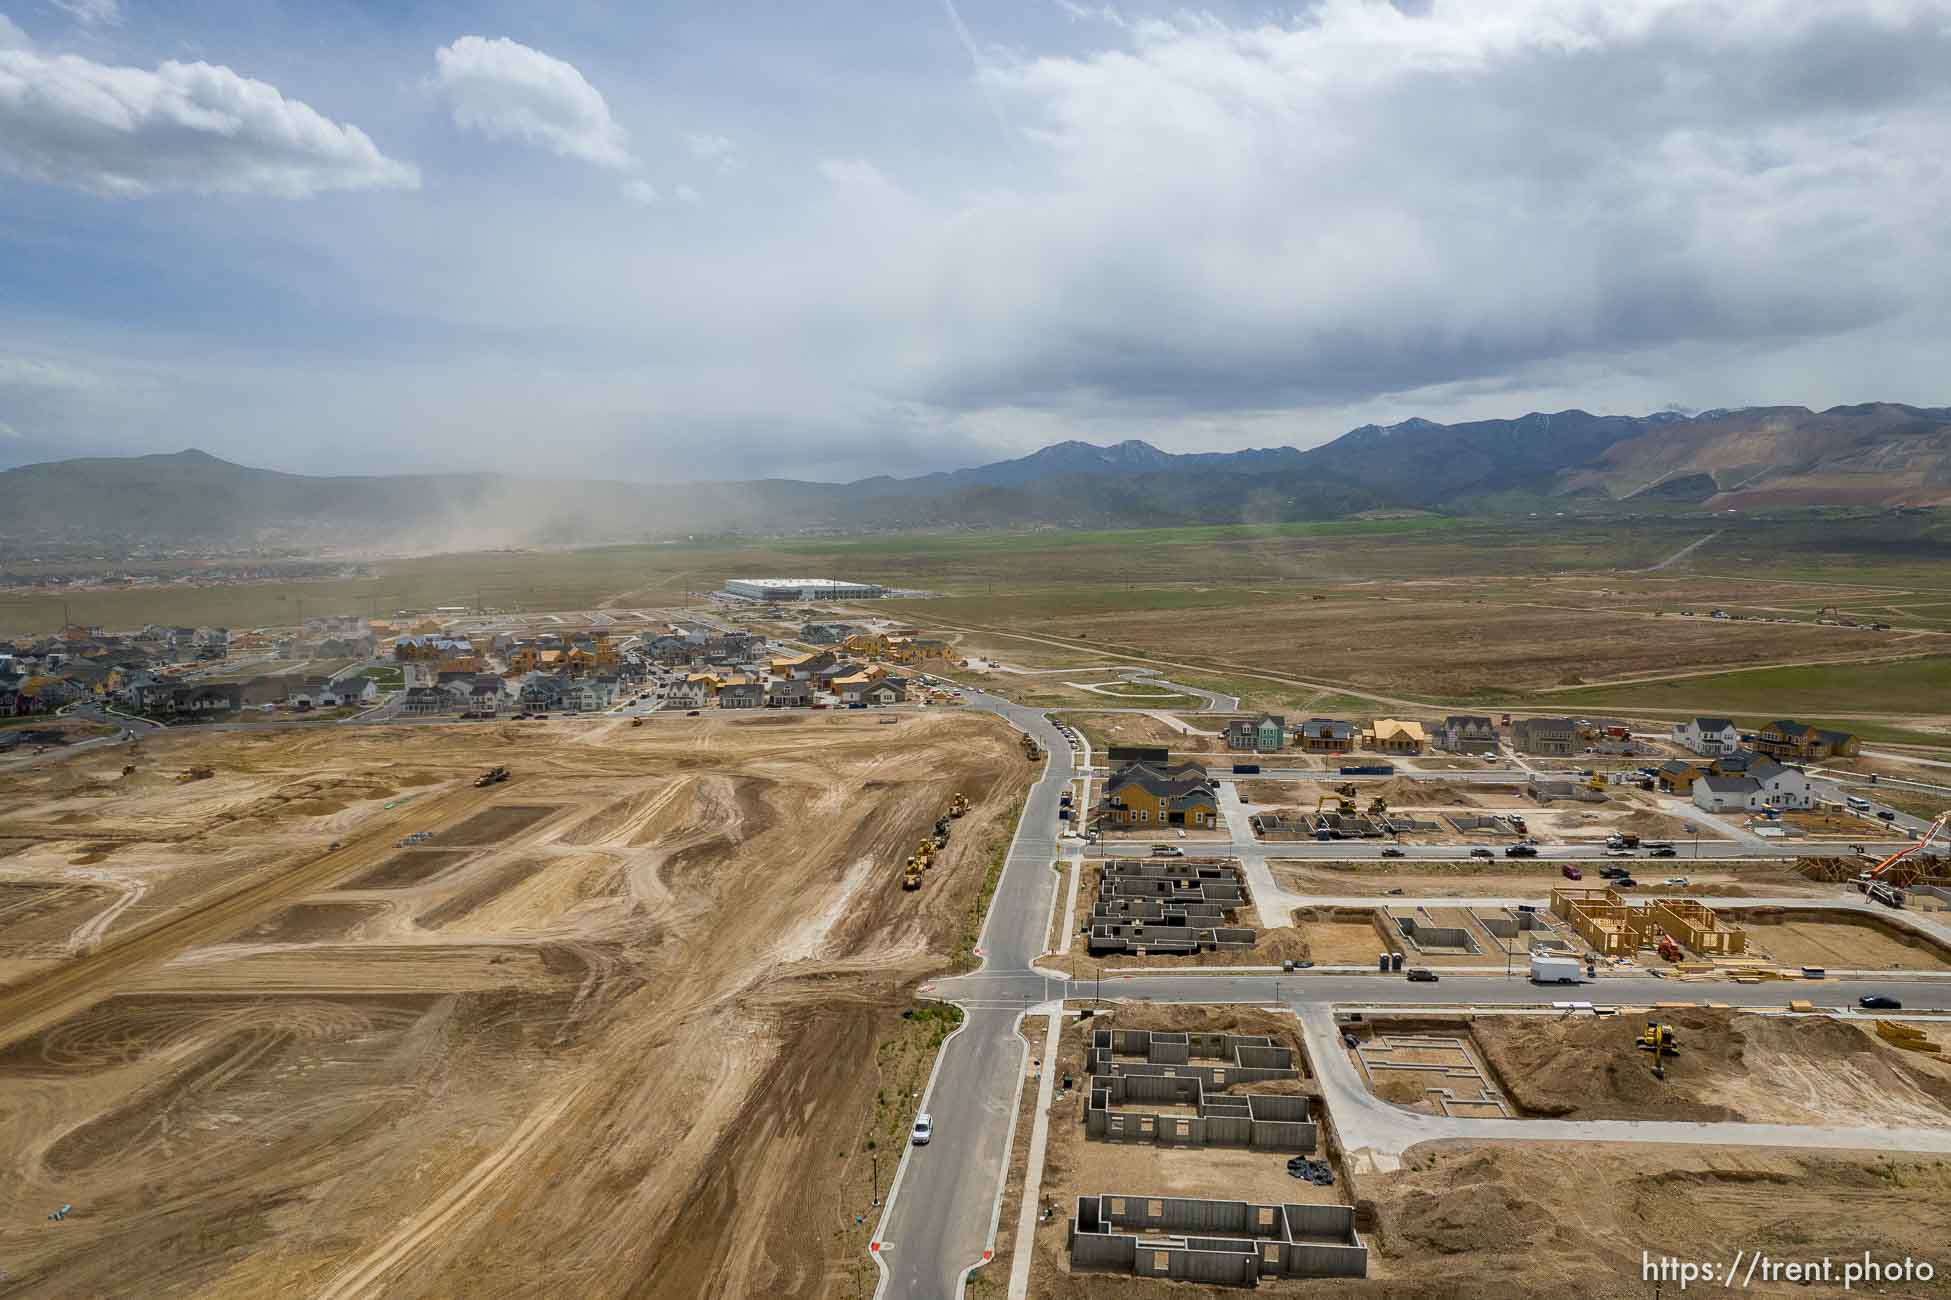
(893, 0), (1951, 408)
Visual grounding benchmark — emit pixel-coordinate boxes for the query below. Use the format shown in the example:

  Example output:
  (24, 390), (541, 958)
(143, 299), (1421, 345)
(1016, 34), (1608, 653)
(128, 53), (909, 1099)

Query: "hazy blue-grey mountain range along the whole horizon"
(0, 404), (1951, 550)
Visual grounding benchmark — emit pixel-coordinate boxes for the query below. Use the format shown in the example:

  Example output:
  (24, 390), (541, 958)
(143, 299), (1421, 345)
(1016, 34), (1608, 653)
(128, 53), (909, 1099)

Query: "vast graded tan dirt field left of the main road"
(0, 712), (1028, 1298)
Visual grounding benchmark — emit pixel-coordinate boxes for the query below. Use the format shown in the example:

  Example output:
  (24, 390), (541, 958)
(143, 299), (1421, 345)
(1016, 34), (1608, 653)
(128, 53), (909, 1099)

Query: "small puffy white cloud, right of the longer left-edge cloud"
(433, 35), (636, 168)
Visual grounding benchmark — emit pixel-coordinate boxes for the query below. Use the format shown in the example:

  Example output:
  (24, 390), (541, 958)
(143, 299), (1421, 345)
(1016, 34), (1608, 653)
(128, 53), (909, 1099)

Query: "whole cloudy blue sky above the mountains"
(0, 0), (1951, 480)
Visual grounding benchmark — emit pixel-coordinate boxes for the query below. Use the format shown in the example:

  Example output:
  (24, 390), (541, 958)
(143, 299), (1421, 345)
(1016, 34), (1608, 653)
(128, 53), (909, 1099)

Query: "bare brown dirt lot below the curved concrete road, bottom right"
(1350, 1142), (1951, 1300)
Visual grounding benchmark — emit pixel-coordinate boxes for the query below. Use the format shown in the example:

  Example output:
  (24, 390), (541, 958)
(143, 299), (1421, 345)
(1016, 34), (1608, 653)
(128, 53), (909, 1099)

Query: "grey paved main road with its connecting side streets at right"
(872, 691), (1951, 1300)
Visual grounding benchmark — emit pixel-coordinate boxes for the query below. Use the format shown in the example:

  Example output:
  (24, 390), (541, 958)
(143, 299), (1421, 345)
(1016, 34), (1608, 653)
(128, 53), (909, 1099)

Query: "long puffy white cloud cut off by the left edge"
(0, 49), (419, 199)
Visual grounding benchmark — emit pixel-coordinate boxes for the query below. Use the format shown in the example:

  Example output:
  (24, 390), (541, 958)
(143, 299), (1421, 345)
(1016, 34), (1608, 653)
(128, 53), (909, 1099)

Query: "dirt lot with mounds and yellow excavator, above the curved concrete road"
(1469, 1009), (1951, 1128)
